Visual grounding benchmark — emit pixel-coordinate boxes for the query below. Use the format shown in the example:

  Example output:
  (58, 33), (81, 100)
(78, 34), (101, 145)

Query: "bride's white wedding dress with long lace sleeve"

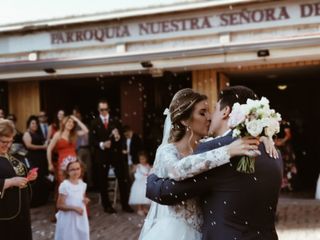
(139, 143), (230, 240)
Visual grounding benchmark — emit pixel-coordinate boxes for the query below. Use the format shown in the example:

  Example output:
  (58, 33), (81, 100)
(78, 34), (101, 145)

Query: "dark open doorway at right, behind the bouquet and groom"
(226, 66), (320, 190)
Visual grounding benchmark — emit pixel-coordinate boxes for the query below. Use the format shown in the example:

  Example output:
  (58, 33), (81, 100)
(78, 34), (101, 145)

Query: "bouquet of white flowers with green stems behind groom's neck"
(229, 97), (281, 173)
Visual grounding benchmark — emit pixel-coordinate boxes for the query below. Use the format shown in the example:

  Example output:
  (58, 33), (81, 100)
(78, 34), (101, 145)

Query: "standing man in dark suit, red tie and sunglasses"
(90, 100), (133, 213)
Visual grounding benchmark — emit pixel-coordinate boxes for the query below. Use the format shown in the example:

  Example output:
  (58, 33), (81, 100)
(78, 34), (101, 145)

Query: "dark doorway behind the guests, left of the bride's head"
(40, 72), (192, 161)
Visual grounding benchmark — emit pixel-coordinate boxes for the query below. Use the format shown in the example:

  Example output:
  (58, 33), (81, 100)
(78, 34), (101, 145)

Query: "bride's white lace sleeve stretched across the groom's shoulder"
(155, 144), (230, 181)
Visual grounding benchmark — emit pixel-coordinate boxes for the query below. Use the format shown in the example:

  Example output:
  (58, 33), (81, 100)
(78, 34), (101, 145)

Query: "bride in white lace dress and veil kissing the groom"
(139, 89), (259, 240)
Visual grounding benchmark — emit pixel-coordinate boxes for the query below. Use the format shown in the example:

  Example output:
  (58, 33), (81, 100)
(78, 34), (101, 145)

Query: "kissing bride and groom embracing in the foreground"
(139, 86), (282, 240)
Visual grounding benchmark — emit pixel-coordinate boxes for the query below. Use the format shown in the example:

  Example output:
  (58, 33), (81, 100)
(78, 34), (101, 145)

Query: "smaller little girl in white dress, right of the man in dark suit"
(129, 152), (151, 216)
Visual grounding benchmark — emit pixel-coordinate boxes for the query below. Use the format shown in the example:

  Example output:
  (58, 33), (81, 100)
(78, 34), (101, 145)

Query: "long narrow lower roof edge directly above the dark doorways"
(0, 35), (320, 73)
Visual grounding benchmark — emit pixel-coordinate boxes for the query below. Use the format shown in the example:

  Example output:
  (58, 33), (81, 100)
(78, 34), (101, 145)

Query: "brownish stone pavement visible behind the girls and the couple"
(31, 193), (320, 240)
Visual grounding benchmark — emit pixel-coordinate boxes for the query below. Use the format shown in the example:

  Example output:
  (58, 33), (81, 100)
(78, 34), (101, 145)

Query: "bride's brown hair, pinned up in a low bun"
(168, 88), (207, 142)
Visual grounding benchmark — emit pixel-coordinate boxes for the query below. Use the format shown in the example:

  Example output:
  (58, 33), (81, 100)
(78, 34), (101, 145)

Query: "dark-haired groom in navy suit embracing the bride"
(147, 86), (282, 240)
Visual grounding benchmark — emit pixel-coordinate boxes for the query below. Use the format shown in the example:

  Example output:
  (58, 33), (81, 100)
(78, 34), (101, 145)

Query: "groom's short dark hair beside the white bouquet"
(218, 86), (258, 110)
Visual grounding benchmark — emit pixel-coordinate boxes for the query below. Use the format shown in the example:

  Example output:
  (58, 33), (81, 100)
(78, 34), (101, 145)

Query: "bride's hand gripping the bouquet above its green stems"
(228, 137), (261, 157)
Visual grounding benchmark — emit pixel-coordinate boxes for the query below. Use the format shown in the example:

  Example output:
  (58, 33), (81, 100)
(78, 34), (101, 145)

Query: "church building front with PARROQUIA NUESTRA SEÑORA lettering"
(0, 0), (320, 186)
